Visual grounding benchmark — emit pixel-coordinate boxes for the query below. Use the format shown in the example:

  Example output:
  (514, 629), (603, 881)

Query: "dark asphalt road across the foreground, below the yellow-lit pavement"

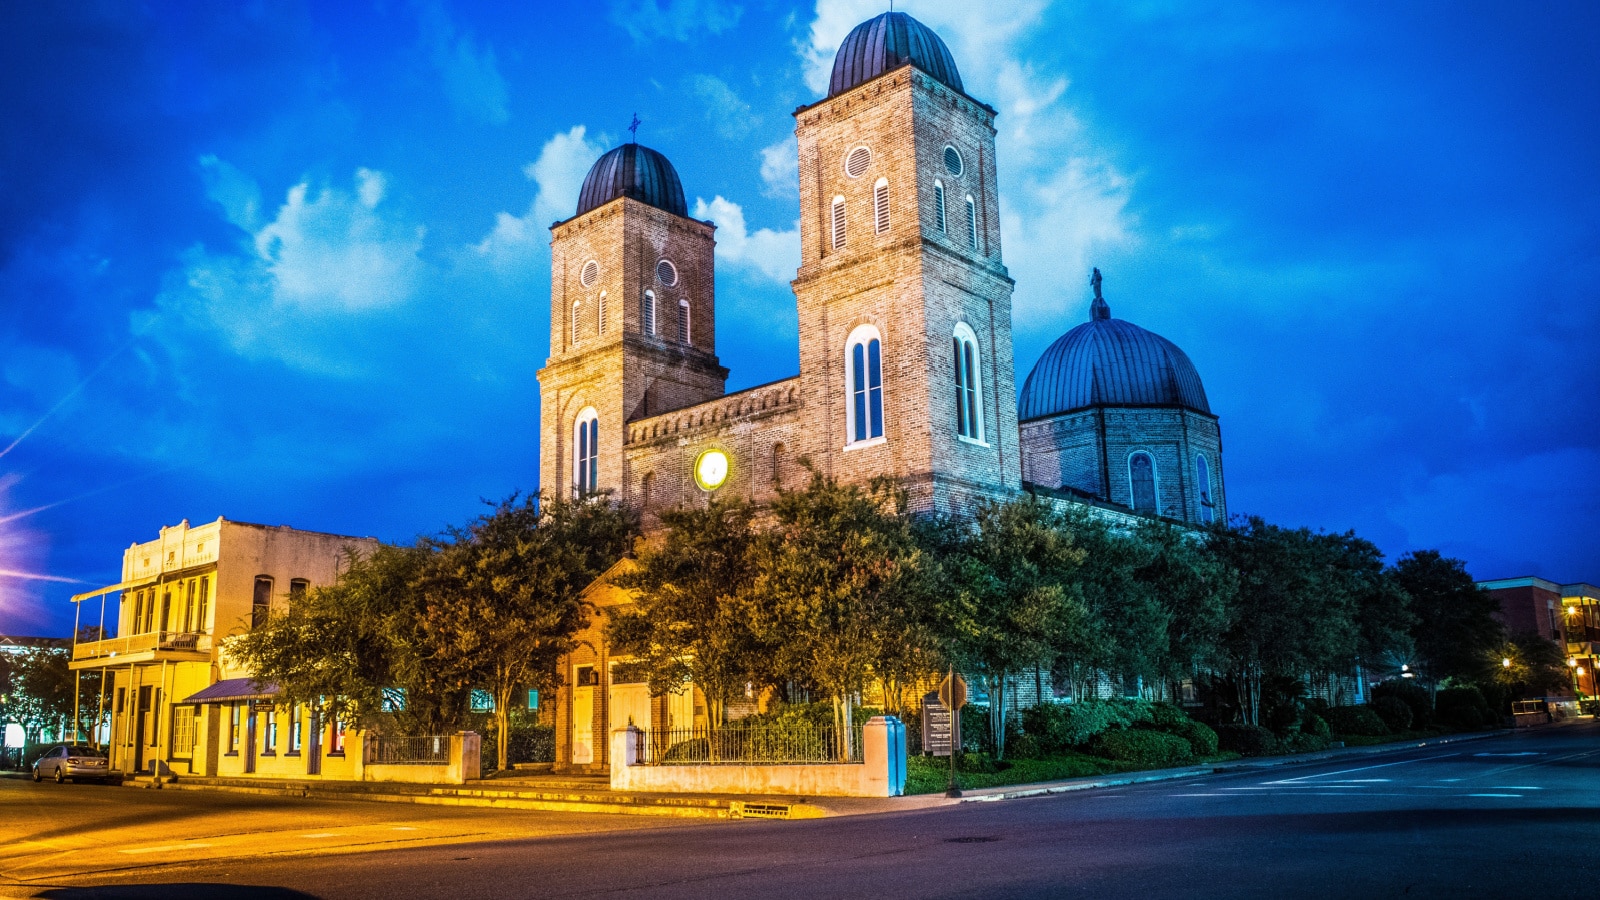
(9, 724), (1600, 900)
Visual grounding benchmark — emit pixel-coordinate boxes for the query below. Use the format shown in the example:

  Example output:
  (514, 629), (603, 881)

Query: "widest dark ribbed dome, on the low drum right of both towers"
(1016, 301), (1211, 421)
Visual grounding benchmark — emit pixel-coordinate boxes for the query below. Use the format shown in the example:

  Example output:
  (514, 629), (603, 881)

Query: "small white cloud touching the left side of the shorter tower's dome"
(474, 125), (605, 269)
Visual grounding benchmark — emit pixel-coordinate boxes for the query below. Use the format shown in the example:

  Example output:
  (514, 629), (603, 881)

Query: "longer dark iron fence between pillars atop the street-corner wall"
(637, 722), (861, 765)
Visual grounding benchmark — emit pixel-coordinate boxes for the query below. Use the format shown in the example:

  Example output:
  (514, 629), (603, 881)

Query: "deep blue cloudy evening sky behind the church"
(0, 0), (1600, 633)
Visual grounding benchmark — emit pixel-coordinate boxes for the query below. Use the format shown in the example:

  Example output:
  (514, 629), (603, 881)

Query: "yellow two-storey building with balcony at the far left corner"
(72, 517), (378, 778)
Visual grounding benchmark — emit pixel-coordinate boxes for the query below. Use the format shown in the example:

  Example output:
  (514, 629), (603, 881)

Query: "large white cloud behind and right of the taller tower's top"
(797, 0), (1138, 333)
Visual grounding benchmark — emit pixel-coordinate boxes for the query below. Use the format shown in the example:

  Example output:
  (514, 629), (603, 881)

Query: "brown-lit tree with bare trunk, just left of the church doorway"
(418, 495), (637, 767)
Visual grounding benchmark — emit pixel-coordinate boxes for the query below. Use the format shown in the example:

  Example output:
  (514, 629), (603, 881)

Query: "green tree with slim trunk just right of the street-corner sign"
(941, 496), (1086, 759)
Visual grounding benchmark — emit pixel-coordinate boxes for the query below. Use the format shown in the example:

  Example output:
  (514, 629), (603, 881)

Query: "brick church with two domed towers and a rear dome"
(539, 13), (1227, 767)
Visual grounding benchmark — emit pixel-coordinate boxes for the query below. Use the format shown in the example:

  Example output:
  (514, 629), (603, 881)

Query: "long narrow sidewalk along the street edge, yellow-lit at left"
(123, 730), (1515, 818)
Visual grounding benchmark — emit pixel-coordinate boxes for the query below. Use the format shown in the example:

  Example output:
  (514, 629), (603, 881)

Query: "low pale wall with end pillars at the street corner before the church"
(611, 716), (906, 798)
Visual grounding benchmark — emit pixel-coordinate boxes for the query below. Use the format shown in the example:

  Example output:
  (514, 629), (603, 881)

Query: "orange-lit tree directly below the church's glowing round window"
(606, 500), (771, 729)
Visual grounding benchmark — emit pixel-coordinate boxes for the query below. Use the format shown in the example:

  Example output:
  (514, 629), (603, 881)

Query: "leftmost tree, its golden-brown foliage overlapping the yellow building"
(226, 534), (435, 730)
